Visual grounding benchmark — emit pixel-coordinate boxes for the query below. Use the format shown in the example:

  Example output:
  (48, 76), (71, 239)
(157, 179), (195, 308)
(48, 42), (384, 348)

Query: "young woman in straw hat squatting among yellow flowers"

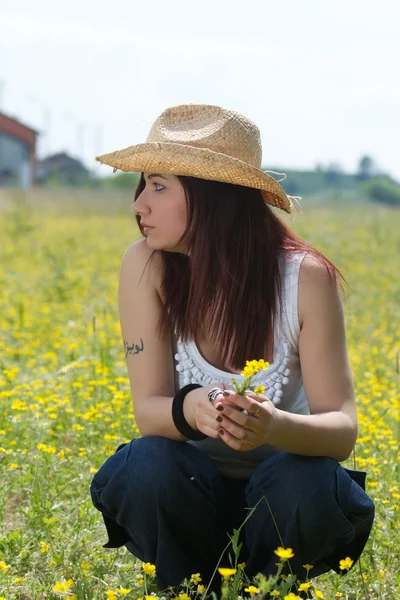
(91, 105), (374, 588)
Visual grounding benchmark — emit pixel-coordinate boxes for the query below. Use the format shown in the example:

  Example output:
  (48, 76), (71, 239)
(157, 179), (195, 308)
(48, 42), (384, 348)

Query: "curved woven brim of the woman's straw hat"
(96, 142), (293, 213)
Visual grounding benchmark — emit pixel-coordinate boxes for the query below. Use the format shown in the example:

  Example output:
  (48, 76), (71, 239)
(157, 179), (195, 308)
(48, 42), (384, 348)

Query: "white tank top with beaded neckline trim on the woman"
(174, 253), (310, 479)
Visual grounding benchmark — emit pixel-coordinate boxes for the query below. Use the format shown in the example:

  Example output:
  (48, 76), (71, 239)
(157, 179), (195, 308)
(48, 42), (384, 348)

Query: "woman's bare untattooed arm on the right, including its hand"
(217, 257), (357, 461)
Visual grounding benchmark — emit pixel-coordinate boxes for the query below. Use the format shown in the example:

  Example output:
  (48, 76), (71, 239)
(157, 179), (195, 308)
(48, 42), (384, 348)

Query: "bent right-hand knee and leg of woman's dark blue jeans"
(246, 452), (374, 576)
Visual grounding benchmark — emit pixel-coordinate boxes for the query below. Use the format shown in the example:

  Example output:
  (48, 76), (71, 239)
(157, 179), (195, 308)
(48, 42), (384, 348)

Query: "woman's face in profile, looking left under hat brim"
(131, 173), (187, 253)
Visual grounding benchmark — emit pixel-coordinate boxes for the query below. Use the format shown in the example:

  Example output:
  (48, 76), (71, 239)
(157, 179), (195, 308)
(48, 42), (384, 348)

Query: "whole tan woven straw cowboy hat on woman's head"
(96, 104), (293, 213)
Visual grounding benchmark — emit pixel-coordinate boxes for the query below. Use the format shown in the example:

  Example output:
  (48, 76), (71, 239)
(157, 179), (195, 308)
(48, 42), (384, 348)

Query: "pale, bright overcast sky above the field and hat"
(0, 0), (400, 180)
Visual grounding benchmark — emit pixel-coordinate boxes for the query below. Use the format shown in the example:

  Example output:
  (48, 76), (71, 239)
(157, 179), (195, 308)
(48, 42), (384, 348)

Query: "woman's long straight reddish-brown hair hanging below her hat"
(135, 173), (343, 370)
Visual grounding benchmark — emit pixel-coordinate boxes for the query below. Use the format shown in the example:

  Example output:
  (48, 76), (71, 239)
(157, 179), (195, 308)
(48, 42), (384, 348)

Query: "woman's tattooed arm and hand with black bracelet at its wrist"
(118, 240), (225, 441)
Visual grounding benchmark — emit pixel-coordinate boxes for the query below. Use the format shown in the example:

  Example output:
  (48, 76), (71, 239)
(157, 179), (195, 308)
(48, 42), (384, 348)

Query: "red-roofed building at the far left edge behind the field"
(0, 112), (38, 188)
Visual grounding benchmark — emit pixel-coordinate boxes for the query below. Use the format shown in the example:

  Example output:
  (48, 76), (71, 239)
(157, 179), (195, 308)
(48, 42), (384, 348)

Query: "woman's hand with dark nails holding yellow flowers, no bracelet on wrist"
(212, 390), (278, 452)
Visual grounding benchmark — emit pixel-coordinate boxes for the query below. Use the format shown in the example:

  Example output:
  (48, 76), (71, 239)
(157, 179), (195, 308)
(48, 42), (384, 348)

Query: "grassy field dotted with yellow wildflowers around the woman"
(0, 191), (400, 600)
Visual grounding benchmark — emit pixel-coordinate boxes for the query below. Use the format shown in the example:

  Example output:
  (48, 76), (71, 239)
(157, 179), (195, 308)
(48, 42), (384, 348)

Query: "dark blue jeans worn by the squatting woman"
(90, 436), (374, 589)
